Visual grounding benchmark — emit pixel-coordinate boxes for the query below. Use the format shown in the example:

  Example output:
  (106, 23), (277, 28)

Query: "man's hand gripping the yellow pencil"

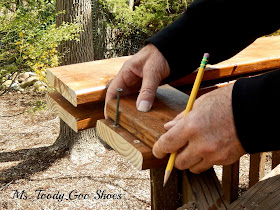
(153, 84), (245, 173)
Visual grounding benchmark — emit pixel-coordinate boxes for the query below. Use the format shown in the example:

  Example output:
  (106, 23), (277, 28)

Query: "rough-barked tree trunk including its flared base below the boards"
(55, 0), (96, 150)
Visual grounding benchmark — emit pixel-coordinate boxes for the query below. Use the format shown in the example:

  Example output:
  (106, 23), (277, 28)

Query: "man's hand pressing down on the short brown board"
(104, 44), (170, 117)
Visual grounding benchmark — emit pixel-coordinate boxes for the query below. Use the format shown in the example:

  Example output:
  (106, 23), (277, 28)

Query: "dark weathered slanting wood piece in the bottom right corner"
(230, 168), (280, 209)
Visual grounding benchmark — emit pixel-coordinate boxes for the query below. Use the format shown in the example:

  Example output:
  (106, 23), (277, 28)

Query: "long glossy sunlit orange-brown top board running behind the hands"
(47, 36), (280, 106)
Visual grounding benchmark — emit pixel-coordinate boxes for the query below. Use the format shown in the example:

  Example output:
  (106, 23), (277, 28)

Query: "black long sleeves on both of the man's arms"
(146, 0), (280, 153)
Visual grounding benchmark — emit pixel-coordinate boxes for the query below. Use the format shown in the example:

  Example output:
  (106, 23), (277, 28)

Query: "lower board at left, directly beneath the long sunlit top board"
(46, 92), (104, 132)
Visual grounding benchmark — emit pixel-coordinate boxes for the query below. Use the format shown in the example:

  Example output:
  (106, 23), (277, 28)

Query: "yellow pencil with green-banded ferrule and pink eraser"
(163, 53), (209, 187)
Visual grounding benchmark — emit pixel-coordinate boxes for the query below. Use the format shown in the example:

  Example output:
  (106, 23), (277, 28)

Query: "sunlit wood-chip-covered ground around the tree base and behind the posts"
(0, 92), (270, 209)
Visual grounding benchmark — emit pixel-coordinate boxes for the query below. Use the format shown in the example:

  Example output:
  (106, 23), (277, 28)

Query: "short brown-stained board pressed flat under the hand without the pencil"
(106, 85), (188, 147)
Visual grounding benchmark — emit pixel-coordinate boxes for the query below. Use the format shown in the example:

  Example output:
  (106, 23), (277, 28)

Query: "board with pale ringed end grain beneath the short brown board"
(96, 119), (168, 170)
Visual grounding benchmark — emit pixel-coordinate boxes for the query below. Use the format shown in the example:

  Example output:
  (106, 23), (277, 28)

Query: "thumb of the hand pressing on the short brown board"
(136, 70), (161, 112)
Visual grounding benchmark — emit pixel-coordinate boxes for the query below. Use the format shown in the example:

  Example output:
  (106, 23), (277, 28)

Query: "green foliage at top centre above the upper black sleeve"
(100, 0), (192, 36)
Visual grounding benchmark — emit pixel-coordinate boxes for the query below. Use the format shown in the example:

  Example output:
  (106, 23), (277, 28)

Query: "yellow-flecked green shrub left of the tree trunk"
(0, 0), (81, 79)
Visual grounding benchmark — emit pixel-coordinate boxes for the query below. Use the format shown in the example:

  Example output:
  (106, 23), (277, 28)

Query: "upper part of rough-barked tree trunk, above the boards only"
(56, 0), (94, 65)
